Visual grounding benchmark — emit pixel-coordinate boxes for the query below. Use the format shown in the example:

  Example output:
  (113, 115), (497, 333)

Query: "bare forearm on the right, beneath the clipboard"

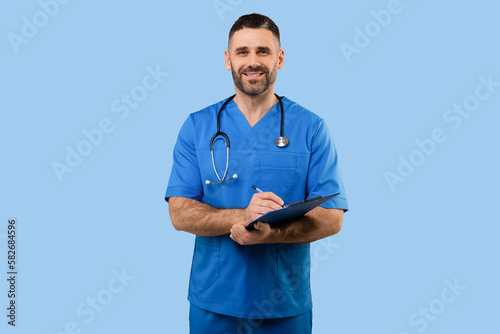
(267, 207), (344, 244)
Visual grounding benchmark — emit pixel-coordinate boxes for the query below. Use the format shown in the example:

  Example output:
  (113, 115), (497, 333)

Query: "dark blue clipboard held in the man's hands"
(245, 193), (340, 231)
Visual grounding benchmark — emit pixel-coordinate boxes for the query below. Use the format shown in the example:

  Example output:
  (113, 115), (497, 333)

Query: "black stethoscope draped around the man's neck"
(205, 93), (290, 185)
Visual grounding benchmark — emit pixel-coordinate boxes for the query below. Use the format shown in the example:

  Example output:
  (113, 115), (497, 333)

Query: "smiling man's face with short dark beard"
(225, 28), (284, 96)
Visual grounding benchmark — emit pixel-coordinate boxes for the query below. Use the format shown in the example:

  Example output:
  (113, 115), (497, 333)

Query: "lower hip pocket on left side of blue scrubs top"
(191, 236), (220, 289)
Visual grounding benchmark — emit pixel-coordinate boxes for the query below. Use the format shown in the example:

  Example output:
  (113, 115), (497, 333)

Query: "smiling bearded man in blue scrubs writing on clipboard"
(165, 14), (348, 334)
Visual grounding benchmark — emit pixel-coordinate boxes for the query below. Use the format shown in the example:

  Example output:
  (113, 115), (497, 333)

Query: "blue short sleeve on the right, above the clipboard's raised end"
(307, 119), (348, 211)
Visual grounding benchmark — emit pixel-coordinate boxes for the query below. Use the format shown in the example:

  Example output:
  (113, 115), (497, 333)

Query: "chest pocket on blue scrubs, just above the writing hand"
(257, 153), (297, 198)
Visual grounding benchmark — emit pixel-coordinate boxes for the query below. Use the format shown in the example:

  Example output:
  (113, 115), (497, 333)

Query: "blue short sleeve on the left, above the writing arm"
(165, 116), (203, 202)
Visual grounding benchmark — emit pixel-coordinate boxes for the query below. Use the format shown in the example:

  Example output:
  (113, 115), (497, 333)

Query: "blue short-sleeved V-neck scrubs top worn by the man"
(165, 97), (348, 319)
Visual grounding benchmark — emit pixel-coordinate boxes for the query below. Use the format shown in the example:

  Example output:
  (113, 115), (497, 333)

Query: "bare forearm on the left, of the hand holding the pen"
(169, 197), (244, 237)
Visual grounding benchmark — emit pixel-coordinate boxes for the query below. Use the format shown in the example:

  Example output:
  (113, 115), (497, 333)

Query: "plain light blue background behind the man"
(0, 0), (500, 334)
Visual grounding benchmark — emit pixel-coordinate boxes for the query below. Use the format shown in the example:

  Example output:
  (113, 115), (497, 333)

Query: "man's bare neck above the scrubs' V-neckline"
(234, 87), (278, 127)
